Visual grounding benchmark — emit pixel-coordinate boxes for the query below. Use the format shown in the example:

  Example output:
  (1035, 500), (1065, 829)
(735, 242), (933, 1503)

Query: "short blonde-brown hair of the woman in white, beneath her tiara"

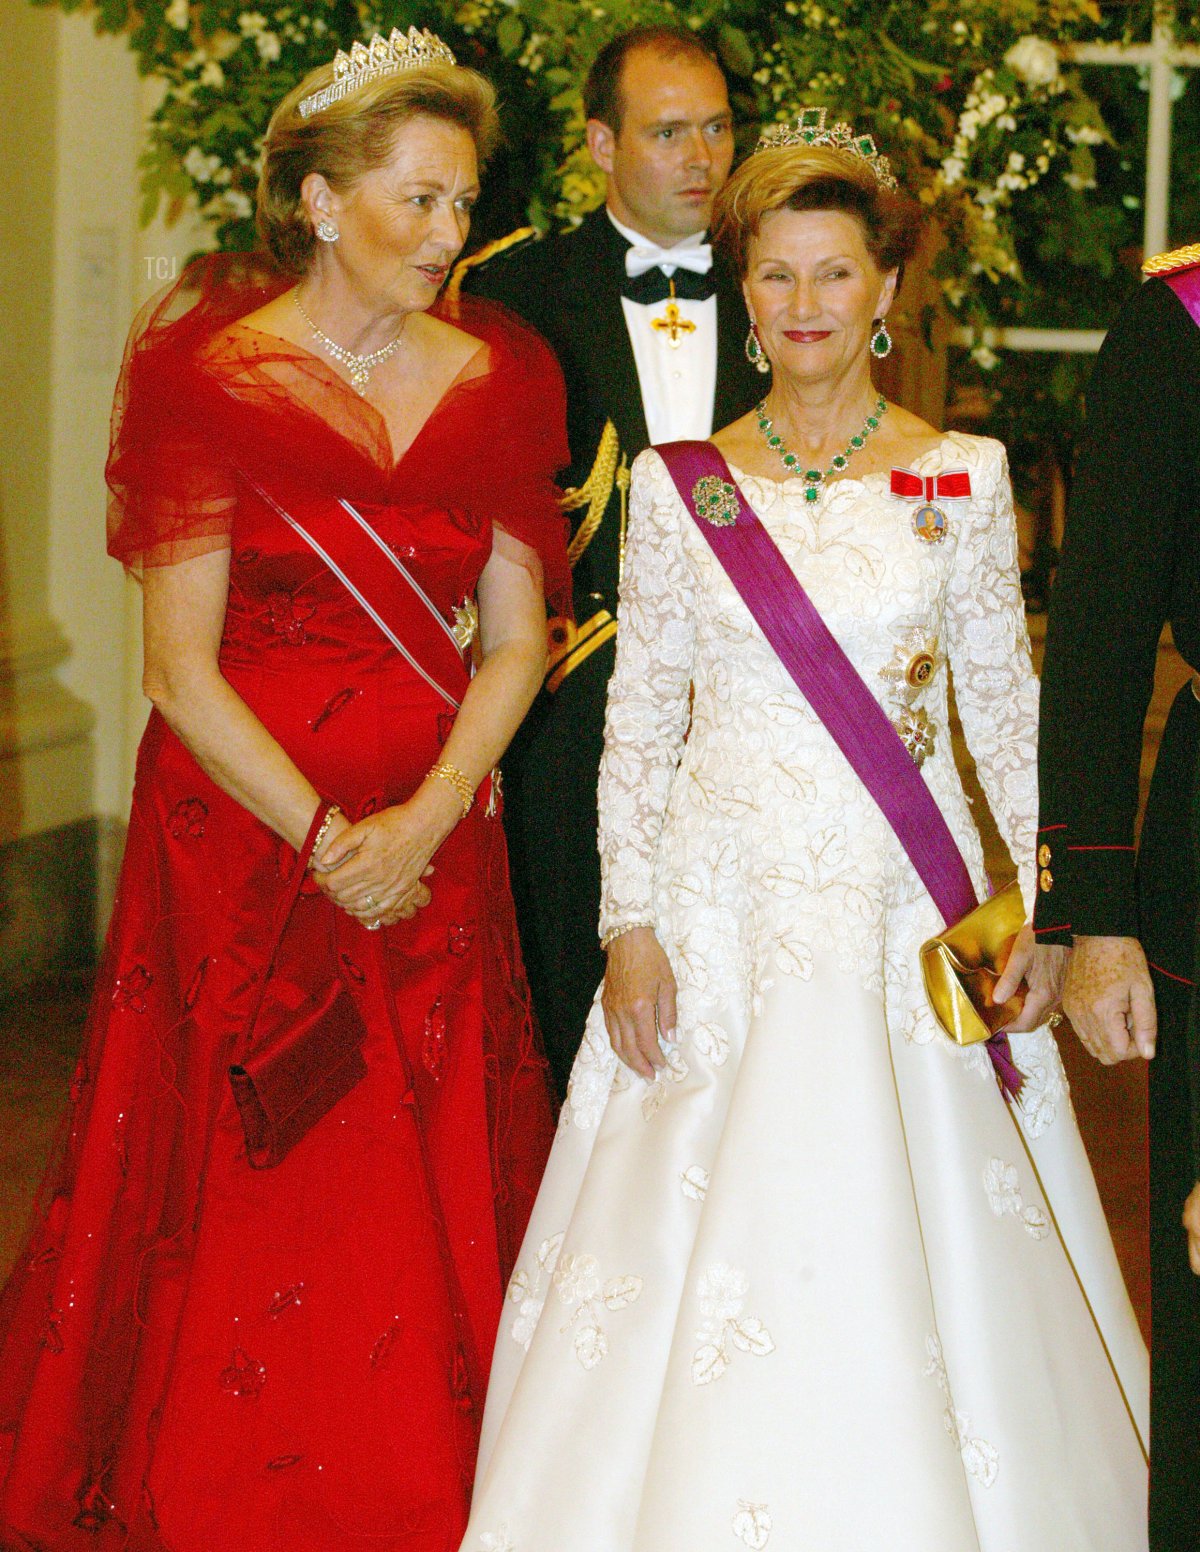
(713, 146), (924, 287)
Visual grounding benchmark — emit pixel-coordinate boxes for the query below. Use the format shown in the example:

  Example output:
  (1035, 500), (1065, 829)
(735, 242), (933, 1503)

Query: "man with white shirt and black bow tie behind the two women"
(458, 26), (765, 1094)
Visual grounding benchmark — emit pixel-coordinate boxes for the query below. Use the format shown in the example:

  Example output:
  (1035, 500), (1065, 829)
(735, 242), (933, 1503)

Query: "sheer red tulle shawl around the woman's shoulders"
(106, 255), (571, 613)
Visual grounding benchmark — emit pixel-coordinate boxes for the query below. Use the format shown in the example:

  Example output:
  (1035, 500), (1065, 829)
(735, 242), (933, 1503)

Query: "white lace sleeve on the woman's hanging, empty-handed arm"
(599, 452), (695, 939)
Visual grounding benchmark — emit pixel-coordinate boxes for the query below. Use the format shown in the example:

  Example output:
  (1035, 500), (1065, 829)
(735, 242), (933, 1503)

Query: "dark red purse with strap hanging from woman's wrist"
(230, 804), (366, 1169)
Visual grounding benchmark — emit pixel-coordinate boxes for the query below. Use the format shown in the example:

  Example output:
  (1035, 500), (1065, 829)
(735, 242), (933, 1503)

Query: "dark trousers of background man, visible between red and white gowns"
(505, 643), (615, 1099)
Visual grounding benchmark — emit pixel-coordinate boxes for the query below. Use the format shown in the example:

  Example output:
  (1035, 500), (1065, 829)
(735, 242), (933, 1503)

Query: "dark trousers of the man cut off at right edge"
(1138, 688), (1200, 1552)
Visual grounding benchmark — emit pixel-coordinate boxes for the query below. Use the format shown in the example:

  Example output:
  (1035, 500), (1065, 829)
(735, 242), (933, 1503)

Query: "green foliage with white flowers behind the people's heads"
(36, 0), (1200, 474)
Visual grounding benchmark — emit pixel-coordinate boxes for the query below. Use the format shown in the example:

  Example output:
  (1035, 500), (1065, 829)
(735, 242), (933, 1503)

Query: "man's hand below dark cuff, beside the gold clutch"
(1062, 937), (1158, 1066)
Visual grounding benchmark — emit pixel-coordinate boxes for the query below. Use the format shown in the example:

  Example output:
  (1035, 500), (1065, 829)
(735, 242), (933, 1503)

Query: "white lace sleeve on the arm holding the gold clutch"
(945, 442), (1039, 916)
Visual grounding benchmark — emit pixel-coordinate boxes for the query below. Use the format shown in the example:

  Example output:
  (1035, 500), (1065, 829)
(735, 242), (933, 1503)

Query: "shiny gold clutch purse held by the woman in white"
(921, 880), (1025, 1046)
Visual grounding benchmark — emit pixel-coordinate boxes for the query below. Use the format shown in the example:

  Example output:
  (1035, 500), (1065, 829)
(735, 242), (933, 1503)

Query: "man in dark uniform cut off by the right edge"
(1035, 245), (1200, 1552)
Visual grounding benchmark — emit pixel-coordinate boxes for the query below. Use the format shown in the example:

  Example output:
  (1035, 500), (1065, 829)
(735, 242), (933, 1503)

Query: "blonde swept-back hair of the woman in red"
(258, 64), (500, 276)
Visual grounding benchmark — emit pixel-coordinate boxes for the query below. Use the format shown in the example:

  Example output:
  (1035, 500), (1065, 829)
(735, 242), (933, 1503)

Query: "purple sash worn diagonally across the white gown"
(655, 442), (1020, 1096)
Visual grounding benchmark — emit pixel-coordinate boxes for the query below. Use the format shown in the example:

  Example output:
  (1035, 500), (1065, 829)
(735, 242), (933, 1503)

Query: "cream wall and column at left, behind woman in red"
(0, 9), (212, 841)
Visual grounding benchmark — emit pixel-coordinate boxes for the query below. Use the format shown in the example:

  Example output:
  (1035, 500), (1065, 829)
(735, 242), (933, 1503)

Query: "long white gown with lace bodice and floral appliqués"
(463, 436), (1147, 1552)
